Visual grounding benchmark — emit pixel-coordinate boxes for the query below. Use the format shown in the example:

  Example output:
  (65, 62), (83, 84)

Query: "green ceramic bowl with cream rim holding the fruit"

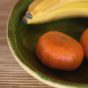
(7, 0), (88, 88)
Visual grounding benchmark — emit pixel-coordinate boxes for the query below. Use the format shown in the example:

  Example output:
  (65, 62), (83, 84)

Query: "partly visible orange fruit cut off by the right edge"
(80, 29), (88, 59)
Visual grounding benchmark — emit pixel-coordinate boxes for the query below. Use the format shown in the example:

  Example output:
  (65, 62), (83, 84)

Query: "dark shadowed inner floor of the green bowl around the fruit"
(16, 18), (88, 83)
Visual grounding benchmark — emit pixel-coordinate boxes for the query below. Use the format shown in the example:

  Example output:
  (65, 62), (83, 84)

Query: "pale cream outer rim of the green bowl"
(6, 0), (88, 88)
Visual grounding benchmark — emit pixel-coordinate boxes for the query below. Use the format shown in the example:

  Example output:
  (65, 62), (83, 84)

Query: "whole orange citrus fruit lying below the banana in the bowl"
(36, 31), (84, 71)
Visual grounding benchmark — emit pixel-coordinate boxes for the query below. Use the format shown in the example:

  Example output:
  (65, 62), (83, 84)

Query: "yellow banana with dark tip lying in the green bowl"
(23, 0), (88, 24)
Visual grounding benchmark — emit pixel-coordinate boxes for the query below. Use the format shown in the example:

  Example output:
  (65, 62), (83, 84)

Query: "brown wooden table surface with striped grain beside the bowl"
(0, 0), (50, 88)
